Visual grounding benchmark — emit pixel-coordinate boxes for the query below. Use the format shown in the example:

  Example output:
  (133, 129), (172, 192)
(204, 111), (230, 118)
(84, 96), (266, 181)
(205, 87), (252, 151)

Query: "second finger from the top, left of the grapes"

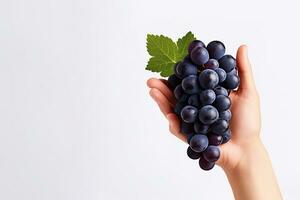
(149, 88), (173, 117)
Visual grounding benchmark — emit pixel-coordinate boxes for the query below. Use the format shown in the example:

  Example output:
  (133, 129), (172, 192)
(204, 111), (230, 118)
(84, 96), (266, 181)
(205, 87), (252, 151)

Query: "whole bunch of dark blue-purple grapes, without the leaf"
(168, 40), (240, 170)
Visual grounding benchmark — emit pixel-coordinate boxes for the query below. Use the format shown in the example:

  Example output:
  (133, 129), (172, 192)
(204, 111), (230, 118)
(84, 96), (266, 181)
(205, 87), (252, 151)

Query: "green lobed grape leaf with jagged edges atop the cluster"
(146, 32), (195, 77)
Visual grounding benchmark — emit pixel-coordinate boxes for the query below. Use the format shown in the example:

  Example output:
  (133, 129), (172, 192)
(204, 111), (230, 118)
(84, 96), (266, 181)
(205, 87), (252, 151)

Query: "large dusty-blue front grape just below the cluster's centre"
(199, 105), (219, 124)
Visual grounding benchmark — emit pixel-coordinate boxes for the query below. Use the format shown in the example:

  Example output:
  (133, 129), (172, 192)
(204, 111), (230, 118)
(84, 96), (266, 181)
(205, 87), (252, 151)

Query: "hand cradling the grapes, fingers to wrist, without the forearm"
(147, 46), (260, 169)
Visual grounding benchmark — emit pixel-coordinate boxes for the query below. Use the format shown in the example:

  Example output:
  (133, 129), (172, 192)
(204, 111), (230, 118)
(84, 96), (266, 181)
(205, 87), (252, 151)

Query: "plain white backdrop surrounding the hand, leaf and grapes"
(0, 0), (300, 200)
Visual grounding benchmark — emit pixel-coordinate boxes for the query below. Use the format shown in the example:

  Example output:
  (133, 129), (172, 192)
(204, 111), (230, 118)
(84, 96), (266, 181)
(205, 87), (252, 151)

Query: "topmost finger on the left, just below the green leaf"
(147, 78), (176, 106)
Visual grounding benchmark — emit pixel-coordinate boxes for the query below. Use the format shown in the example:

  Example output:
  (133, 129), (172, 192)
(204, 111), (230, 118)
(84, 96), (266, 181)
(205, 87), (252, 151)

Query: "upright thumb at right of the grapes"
(236, 45), (255, 93)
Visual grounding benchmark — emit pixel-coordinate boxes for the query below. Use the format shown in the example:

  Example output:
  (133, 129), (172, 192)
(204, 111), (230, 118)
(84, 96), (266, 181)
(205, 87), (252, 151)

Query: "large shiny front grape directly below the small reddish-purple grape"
(199, 69), (219, 89)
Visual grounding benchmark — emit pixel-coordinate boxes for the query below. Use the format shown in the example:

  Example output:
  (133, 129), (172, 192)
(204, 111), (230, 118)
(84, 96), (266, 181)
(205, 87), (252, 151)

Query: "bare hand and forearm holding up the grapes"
(147, 45), (282, 200)
